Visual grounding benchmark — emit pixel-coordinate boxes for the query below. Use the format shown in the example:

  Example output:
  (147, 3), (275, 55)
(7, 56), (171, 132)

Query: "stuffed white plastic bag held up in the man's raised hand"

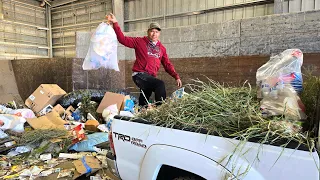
(82, 22), (119, 71)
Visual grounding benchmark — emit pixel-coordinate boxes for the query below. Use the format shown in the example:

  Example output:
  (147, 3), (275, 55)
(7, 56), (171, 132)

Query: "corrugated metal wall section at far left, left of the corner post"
(0, 0), (49, 60)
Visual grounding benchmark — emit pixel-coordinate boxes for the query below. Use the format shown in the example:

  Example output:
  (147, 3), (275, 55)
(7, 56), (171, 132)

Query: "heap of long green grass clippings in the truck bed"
(138, 79), (309, 146)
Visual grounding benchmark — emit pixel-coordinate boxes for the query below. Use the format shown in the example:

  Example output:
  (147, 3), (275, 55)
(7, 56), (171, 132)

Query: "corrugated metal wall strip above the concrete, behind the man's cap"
(125, 0), (274, 31)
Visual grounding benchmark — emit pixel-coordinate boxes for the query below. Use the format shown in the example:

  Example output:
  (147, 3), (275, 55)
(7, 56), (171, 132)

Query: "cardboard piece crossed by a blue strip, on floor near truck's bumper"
(73, 156), (101, 174)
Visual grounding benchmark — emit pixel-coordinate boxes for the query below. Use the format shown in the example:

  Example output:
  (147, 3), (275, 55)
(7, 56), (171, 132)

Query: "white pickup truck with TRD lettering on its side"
(107, 117), (319, 180)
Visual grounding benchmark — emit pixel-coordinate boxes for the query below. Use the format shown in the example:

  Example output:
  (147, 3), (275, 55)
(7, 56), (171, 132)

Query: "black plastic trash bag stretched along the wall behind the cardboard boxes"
(56, 89), (130, 108)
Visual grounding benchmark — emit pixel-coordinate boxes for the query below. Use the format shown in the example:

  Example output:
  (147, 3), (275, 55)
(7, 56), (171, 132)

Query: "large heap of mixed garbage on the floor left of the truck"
(0, 84), (136, 180)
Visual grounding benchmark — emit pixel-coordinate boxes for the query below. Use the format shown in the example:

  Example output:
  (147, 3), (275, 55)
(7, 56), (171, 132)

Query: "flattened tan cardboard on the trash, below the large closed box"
(27, 111), (67, 130)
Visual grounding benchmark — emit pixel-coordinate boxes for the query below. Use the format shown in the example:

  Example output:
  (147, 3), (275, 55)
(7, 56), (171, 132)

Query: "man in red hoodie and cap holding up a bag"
(107, 13), (182, 106)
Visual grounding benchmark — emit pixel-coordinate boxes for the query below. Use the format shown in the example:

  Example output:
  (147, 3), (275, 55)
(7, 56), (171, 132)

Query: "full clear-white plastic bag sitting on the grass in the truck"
(256, 49), (306, 120)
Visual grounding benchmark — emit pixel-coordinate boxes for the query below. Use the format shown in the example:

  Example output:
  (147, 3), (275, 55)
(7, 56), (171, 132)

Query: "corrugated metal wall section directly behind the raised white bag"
(51, 0), (112, 57)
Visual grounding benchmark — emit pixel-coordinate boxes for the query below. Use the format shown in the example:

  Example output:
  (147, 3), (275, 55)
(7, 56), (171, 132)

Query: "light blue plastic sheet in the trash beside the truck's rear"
(70, 132), (108, 152)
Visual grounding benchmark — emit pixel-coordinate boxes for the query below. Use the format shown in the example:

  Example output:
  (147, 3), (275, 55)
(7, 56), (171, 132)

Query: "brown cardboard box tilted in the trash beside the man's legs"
(97, 92), (125, 113)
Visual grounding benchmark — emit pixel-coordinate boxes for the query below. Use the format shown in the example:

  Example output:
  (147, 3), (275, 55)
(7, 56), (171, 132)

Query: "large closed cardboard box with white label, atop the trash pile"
(25, 84), (67, 113)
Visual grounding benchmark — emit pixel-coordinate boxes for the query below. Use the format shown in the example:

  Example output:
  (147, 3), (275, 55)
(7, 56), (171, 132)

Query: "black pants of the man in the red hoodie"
(132, 73), (166, 106)
